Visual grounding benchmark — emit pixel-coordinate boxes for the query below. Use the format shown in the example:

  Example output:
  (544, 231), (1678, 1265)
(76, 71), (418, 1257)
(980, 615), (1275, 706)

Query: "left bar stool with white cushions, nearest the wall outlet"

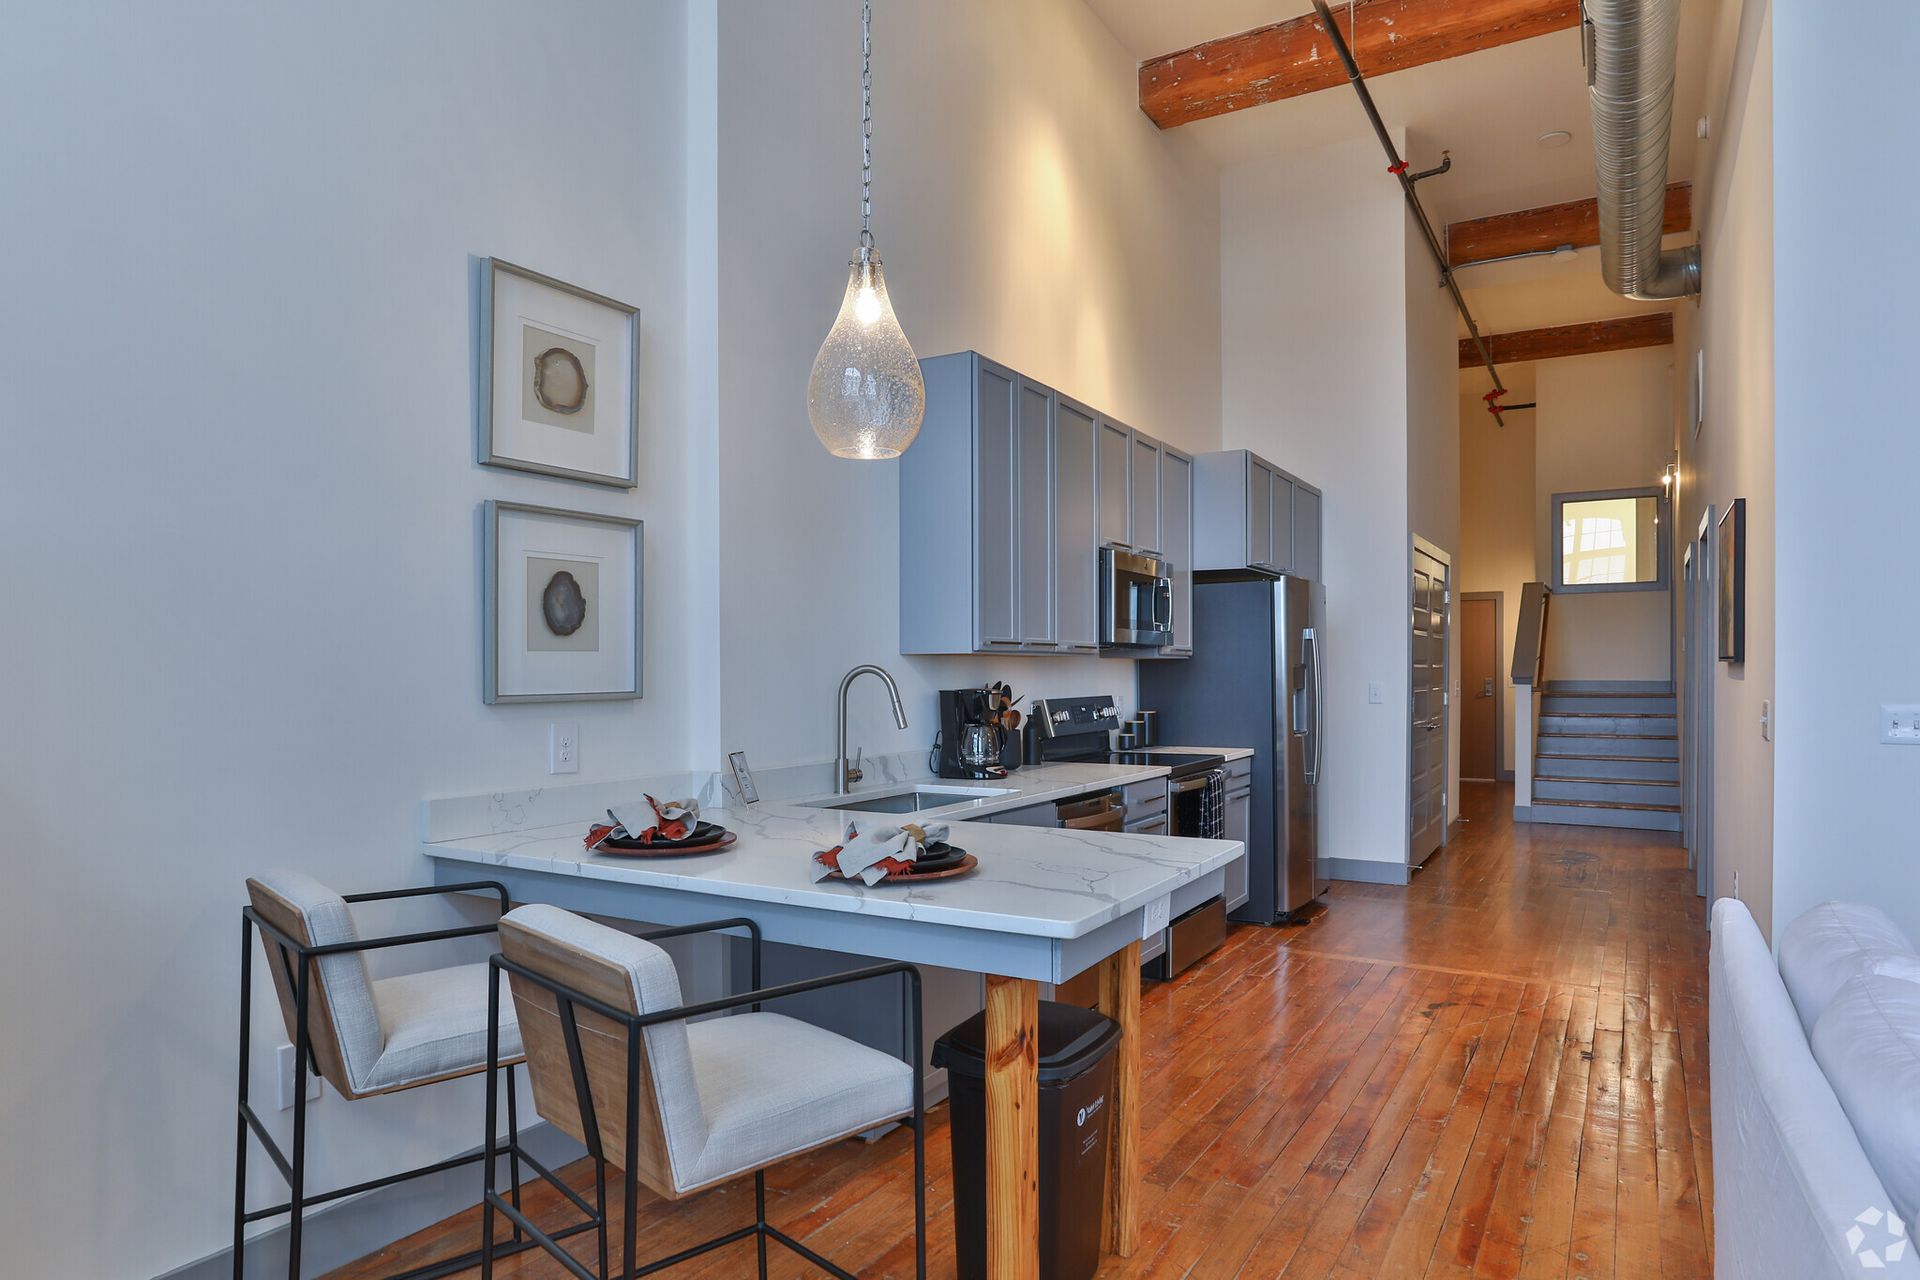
(234, 871), (591, 1280)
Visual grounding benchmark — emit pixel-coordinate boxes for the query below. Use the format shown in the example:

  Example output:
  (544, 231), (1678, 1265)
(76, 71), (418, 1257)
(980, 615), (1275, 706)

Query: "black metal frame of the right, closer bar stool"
(480, 917), (927, 1280)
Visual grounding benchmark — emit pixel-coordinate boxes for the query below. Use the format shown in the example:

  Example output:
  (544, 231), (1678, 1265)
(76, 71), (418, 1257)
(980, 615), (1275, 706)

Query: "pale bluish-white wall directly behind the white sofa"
(1766, 2), (1920, 936)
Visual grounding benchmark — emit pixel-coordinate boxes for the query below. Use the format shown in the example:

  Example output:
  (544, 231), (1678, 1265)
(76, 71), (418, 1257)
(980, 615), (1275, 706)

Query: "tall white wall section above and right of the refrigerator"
(1221, 138), (1420, 865)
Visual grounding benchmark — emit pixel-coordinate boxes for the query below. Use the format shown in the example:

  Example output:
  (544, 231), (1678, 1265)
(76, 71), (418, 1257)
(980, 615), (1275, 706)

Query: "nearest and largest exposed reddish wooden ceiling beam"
(1140, 0), (1580, 129)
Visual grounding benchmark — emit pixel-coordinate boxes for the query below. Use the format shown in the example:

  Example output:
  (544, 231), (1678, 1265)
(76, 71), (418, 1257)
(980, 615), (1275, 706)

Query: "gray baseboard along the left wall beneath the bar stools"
(156, 1121), (586, 1280)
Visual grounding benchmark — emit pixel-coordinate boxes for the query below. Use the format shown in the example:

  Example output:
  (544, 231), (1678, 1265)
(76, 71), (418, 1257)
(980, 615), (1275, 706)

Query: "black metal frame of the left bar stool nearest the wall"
(234, 881), (593, 1280)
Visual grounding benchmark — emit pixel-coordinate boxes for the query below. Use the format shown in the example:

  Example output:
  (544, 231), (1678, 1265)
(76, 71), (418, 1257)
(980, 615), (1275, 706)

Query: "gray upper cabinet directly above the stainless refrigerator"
(1194, 449), (1321, 580)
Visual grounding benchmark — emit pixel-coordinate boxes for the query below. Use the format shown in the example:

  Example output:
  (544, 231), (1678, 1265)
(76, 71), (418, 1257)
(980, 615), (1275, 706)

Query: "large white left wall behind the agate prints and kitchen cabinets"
(0, 0), (1221, 1276)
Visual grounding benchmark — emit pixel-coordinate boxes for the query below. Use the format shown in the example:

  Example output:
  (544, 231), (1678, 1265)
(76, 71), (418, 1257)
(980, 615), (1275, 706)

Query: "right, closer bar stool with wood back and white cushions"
(480, 904), (927, 1280)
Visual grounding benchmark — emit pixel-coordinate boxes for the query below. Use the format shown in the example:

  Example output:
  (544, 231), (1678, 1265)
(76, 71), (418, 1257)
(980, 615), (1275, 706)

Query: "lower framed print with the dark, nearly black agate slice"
(482, 501), (641, 704)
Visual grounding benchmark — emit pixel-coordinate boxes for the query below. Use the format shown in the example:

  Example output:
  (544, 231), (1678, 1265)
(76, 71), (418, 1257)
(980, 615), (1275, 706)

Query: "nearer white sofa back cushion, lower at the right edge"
(1812, 973), (1920, 1222)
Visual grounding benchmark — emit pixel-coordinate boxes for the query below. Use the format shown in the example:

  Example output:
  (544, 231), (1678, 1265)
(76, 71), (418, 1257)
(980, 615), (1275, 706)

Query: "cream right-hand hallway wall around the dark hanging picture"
(1676, 0), (1774, 933)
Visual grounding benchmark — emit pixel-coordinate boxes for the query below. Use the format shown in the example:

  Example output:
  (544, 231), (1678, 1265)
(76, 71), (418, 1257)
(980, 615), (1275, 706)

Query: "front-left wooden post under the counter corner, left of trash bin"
(987, 973), (1041, 1280)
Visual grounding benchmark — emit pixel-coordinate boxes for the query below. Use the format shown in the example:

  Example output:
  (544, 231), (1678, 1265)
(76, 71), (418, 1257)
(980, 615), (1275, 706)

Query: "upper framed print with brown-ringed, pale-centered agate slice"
(476, 257), (639, 489)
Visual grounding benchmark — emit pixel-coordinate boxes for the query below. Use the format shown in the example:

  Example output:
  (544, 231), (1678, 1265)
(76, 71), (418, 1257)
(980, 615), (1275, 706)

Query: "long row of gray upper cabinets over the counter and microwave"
(900, 351), (1192, 656)
